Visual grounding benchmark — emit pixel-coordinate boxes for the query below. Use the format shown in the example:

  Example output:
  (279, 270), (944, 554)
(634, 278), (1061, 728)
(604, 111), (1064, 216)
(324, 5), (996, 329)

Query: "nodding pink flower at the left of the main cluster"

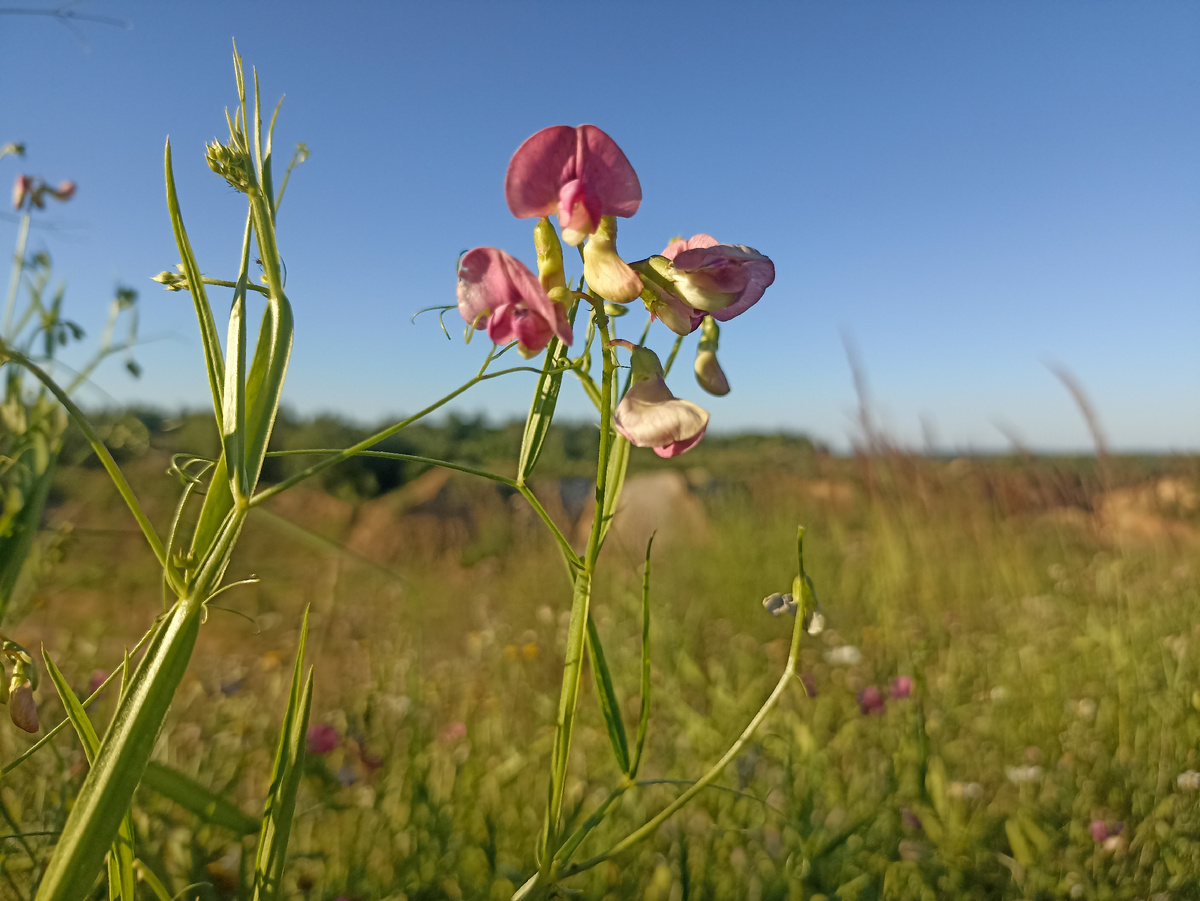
(458, 247), (572, 356)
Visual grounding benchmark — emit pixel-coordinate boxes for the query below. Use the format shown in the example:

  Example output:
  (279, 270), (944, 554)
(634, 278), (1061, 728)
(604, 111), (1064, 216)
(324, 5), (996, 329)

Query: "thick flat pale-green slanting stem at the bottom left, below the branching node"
(37, 602), (202, 901)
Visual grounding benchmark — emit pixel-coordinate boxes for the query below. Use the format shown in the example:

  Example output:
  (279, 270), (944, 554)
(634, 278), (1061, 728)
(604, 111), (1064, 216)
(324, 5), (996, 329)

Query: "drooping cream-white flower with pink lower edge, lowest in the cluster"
(612, 341), (708, 457)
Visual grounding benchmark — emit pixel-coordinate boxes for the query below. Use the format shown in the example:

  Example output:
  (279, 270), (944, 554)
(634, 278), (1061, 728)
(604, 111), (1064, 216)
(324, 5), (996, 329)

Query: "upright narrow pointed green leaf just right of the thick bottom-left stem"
(253, 608), (312, 901)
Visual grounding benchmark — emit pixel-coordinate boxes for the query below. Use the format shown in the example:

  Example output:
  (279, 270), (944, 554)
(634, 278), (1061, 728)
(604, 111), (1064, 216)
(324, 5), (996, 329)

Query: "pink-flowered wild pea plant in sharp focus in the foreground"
(4, 53), (822, 901)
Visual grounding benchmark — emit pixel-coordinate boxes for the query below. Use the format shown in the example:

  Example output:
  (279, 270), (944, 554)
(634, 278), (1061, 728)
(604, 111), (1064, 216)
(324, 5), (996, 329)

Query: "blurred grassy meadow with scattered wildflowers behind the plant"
(0, 416), (1200, 901)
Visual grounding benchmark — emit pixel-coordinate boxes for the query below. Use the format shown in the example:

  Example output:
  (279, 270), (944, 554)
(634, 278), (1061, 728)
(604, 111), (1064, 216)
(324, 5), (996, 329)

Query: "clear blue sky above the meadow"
(0, 0), (1200, 451)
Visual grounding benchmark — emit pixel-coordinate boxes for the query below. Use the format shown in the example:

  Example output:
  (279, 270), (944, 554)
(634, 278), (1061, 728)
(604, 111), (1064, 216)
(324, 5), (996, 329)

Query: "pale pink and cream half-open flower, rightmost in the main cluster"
(662, 234), (775, 323)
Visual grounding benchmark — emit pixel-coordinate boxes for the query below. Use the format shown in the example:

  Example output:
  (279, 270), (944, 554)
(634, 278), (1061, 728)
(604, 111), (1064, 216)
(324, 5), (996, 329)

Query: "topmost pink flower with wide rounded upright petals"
(504, 125), (642, 246)
